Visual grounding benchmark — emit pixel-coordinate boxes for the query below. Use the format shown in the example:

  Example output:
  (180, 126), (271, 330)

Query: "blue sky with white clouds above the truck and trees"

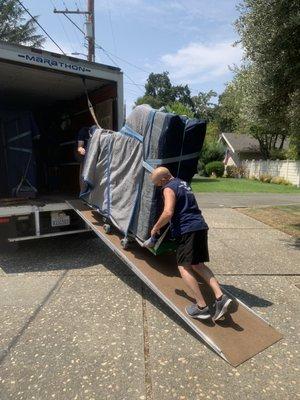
(23, 0), (242, 110)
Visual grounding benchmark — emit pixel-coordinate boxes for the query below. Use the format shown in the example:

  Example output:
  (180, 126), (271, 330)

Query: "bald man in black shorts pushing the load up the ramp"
(150, 167), (232, 321)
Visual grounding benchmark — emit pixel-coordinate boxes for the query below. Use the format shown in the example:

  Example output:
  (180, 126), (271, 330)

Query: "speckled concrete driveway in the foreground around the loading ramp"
(0, 208), (300, 400)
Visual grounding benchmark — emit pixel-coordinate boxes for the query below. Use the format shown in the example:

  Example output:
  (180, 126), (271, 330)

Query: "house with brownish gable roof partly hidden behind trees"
(219, 132), (262, 167)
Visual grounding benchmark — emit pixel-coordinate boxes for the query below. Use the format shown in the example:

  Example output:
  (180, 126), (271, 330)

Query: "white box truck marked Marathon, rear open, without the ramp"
(0, 42), (124, 242)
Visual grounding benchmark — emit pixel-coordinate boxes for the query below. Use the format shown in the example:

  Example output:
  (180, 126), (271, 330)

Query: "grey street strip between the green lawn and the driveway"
(196, 189), (300, 208)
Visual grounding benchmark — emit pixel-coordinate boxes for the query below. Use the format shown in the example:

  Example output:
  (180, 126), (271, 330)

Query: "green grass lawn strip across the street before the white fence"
(192, 177), (300, 194)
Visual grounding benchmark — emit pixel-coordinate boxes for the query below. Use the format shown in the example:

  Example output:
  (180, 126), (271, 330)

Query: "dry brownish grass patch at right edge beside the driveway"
(239, 205), (300, 238)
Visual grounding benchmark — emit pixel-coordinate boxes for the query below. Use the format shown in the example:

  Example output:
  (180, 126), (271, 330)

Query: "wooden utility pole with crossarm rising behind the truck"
(53, 0), (95, 61)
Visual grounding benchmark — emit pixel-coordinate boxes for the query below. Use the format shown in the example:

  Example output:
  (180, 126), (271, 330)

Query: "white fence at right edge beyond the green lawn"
(243, 160), (300, 187)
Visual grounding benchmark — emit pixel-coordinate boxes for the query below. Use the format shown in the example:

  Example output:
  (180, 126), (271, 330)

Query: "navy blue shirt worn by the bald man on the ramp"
(163, 178), (208, 237)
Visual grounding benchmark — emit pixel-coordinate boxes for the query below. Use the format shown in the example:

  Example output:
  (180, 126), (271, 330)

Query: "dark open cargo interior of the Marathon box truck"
(0, 58), (117, 201)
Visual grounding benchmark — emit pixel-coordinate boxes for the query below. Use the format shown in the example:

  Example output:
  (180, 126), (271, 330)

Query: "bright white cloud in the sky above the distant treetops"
(161, 42), (242, 84)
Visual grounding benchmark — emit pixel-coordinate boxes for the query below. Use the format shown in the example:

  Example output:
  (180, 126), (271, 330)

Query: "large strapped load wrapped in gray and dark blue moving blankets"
(81, 105), (206, 241)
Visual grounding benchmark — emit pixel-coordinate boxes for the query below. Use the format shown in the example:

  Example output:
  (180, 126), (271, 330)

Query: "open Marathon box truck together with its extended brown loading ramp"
(0, 42), (282, 366)
